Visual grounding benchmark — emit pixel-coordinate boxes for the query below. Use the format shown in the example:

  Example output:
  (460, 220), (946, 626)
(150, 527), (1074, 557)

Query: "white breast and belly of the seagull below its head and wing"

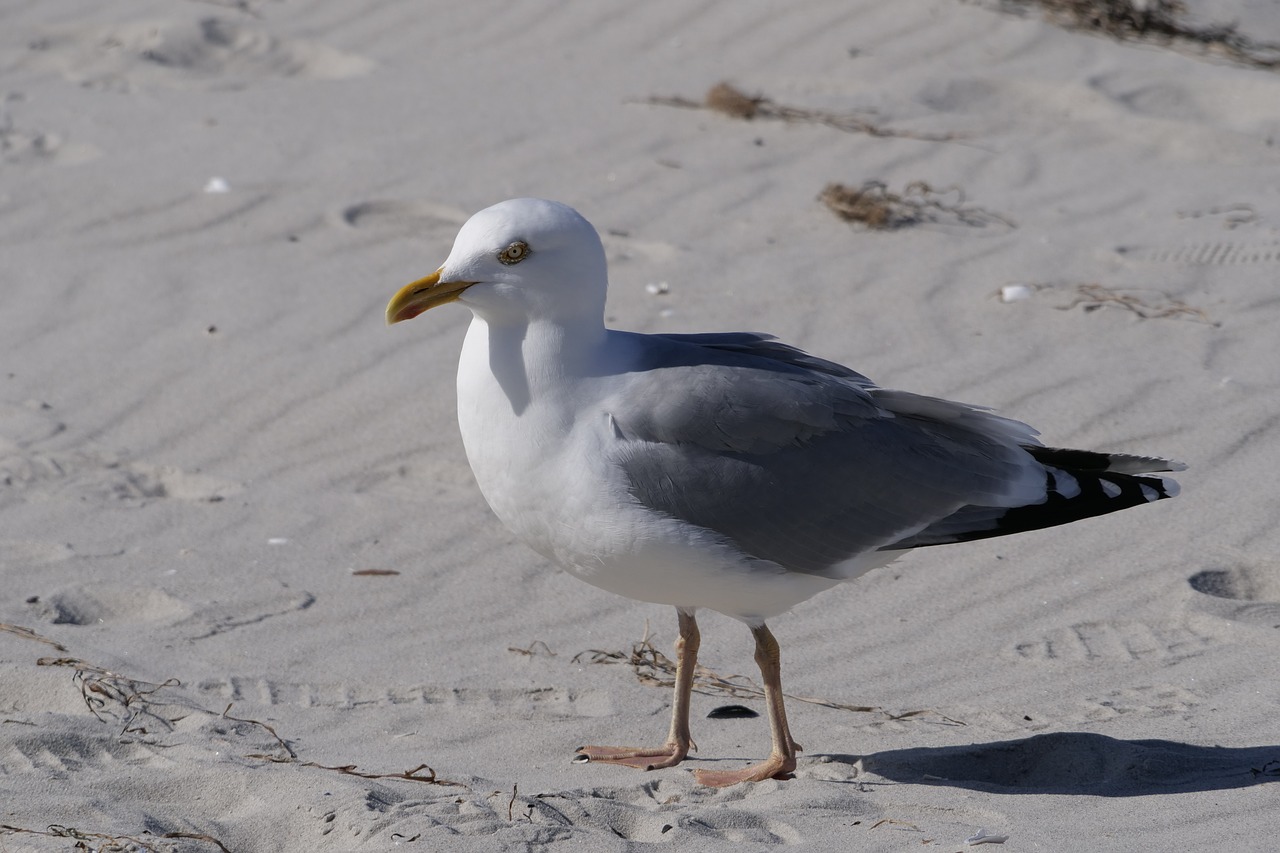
(458, 319), (838, 622)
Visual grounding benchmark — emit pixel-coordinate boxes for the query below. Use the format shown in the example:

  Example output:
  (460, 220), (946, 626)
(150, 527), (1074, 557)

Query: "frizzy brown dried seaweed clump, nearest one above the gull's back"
(818, 181), (1014, 231)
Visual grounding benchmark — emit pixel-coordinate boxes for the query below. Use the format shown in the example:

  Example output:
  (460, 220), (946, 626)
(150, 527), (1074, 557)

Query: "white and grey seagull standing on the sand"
(387, 199), (1185, 788)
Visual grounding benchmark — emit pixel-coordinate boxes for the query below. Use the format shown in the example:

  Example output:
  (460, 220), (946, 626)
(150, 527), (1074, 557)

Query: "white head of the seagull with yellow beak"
(387, 199), (608, 324)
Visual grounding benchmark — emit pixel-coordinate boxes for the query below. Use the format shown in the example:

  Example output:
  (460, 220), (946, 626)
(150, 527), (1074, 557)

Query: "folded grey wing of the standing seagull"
(608, 334), (1044, 578)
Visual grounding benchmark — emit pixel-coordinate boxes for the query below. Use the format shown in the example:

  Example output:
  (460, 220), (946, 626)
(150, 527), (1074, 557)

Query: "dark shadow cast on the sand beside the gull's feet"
(832, 731), (1280, 797)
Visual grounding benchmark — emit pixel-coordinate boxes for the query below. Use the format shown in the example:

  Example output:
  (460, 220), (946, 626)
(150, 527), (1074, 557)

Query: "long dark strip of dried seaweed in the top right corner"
(1001, 0), (1280, 69)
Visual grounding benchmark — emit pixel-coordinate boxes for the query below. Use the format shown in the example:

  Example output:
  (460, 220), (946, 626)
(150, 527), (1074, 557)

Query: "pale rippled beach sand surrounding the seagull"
(0, 0), (1280, 853)
